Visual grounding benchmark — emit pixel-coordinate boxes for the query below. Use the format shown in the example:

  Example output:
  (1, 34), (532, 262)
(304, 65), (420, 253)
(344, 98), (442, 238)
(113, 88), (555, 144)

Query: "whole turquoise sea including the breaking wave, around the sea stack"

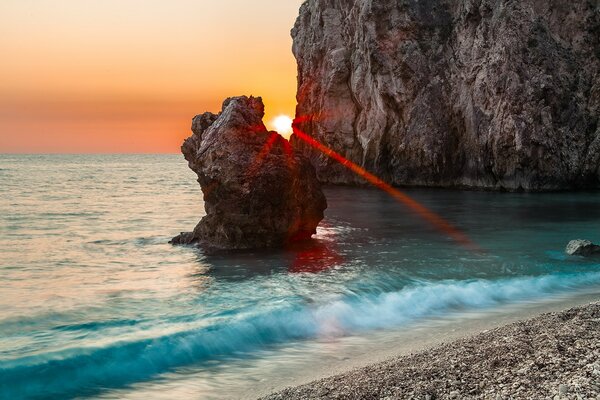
(0, 155), (600, 399)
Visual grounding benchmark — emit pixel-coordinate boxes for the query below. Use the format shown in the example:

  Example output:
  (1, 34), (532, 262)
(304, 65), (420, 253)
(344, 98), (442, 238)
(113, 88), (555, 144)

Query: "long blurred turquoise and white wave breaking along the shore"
(0, 272), (600, 399)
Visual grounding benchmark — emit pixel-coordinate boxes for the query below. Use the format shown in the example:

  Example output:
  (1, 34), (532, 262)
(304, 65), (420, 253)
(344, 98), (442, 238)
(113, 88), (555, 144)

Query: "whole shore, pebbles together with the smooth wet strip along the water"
(258, 290), (600, 400)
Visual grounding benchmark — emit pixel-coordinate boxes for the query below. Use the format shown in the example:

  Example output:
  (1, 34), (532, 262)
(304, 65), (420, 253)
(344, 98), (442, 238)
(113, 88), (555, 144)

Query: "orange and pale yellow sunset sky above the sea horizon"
(0, 0), (303, 153)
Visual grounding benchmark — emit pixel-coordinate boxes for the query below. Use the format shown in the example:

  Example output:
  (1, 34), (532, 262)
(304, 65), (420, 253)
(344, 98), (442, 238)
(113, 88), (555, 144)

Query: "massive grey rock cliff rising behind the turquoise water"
(292, 0), (600, 190)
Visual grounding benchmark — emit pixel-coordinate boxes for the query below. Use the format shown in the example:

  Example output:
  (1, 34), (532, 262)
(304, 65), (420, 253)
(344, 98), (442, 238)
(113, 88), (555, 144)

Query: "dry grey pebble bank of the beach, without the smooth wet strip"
(263, 302), (600, 400)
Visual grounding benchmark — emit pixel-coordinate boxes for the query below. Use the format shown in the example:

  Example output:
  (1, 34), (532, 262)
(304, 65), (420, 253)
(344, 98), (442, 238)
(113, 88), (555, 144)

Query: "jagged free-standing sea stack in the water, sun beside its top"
(172, 97), (327, 251)
